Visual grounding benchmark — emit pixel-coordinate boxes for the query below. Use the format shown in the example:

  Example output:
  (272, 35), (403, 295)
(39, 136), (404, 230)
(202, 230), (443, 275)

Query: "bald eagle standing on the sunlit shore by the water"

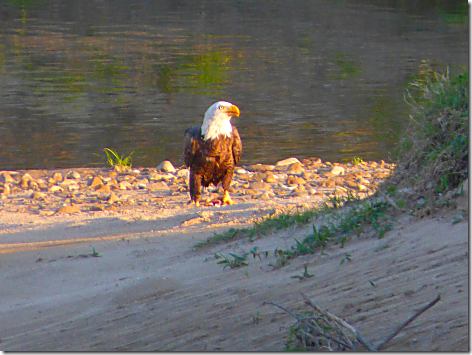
(184, 101), (242, 207)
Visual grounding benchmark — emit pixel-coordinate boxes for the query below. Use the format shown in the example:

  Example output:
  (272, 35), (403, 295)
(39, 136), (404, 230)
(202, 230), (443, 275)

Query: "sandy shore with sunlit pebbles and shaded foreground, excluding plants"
(0, 160), (468, 351)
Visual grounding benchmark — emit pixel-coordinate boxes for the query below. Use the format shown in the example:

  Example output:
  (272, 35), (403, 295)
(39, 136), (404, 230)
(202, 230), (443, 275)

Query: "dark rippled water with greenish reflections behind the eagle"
(0, 0), (469, 170)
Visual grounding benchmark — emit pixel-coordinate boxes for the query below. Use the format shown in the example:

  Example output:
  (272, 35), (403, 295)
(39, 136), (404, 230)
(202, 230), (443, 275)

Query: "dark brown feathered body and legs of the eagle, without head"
(184, 126), (242, 206)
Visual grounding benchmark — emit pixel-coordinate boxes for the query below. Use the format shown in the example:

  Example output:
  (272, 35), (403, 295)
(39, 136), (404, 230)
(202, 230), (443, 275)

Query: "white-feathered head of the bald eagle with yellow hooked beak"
(202, 101), (239, 140)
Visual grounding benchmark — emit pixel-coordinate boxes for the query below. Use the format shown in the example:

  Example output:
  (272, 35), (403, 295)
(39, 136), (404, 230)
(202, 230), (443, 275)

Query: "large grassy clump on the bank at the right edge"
(386, 71), (469, 210)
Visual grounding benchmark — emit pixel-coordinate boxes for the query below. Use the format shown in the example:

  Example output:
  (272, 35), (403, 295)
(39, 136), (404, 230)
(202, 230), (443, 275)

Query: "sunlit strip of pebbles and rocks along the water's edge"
(0, 158), (394, 216)
